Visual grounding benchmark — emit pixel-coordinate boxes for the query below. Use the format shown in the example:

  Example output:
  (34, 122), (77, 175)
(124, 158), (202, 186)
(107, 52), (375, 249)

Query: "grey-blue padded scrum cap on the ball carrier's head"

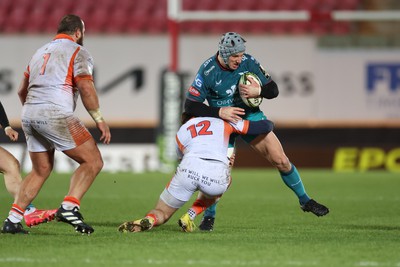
(218, 32), (246, 66)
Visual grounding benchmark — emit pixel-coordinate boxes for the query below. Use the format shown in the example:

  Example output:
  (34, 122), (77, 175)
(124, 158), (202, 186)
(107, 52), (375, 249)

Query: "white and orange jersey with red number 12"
(176, 117), (249, 164)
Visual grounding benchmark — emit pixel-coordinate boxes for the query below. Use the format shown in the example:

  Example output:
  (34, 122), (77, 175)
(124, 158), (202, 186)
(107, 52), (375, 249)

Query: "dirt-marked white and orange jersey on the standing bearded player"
(24, 34), (93, 112)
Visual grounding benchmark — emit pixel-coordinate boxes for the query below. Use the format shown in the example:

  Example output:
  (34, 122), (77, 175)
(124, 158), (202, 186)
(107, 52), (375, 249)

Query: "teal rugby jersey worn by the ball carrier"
(186, 54), (271, 117)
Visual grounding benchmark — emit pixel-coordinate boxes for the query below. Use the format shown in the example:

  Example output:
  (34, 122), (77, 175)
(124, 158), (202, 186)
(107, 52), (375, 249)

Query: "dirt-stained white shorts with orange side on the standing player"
(22, 104), (92, 152)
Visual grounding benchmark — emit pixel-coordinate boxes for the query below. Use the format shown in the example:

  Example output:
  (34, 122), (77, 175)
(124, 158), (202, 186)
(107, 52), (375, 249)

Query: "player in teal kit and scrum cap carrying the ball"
(185, 32), (329, 231)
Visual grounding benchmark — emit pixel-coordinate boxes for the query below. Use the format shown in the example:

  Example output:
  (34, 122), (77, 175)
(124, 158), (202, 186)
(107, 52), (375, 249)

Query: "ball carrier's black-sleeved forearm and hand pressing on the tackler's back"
(185, 98), (245, 122)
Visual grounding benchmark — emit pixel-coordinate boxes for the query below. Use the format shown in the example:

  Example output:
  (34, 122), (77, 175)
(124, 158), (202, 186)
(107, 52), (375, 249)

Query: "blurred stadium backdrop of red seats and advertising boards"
(0, 0), (400, 172)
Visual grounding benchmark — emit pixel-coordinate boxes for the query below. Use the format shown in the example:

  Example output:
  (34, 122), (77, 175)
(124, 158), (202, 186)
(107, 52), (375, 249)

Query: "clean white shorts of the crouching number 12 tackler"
(161, 157), (230, 208)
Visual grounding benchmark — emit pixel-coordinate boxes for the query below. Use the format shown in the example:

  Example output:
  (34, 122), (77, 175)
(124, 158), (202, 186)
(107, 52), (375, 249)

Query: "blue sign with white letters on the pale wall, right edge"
(367, 63), (400, 92)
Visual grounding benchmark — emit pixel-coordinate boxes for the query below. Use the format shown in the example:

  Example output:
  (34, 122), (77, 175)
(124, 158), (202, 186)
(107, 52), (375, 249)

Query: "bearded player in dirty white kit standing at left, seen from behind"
(2, 15), (111, 234)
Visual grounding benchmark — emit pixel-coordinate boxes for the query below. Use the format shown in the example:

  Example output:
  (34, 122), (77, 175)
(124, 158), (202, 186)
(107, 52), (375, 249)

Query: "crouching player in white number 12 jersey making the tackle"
(118, 113), (273, 232)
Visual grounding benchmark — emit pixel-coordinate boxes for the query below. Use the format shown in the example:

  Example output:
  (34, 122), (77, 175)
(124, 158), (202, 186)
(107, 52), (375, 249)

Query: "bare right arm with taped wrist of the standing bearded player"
(76, 79), (111, 144)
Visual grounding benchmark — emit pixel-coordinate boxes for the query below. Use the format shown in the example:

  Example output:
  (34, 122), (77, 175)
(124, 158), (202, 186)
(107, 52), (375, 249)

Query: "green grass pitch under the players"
(0, 169), (400, 267)
